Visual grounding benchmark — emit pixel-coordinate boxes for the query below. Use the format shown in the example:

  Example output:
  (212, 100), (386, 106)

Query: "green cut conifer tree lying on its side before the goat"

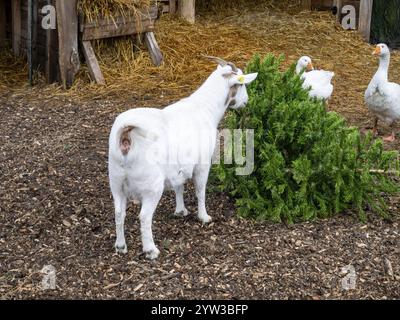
(214, 55), (399, 223)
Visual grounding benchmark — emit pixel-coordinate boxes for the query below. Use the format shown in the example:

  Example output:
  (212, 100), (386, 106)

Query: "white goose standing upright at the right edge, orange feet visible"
(365, 43), (400, 142)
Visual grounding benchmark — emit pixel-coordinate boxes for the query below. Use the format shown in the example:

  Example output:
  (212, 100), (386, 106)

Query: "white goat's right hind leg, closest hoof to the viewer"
(140, 192), (162, 260)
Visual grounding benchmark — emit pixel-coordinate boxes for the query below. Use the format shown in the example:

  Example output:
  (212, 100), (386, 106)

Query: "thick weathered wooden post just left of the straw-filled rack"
(56, 0), (80, 89)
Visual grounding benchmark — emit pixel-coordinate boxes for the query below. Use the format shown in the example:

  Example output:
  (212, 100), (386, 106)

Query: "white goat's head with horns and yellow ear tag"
(205, 56), (258, 109)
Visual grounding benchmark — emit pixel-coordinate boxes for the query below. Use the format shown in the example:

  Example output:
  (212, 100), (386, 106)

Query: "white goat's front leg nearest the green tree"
(193, 165), (211, 223)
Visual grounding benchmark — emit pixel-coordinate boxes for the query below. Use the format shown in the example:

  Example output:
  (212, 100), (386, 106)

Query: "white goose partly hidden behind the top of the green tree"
(296, 56), (335, 101)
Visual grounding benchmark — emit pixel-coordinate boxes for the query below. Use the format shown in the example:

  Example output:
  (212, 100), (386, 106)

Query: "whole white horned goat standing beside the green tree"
(109, 57), (257, 259)
